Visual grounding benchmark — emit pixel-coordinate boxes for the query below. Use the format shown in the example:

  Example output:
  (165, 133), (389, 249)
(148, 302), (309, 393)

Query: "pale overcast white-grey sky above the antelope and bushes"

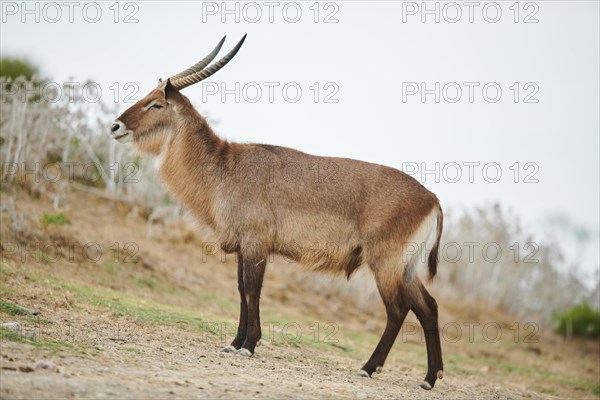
(1, 1), (600, 255)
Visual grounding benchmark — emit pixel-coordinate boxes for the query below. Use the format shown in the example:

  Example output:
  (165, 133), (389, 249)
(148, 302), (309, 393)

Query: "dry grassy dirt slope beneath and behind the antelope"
(0, 184), (600, 399)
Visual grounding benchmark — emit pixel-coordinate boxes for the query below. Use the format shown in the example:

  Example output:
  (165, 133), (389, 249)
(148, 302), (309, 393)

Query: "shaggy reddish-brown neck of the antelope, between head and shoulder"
(159, 110), (231, 228)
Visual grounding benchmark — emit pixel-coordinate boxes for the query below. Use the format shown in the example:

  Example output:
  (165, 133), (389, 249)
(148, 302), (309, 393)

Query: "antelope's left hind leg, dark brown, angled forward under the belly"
(359, 270), (410, 376)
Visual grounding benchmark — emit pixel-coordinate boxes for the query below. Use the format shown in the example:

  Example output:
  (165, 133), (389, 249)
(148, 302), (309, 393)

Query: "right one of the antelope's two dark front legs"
(237, 256), (267, 356)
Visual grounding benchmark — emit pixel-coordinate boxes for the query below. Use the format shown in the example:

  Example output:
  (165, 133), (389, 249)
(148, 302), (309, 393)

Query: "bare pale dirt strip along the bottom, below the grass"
(1, 330), (538, 399)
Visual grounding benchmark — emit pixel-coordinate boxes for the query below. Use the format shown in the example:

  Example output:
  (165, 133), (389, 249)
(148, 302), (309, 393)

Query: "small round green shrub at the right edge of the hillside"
(554, 304), (600, 338)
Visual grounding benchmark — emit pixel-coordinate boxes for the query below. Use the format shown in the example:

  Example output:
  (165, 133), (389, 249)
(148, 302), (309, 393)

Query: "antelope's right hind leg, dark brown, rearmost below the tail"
(410, 280), (444, 390)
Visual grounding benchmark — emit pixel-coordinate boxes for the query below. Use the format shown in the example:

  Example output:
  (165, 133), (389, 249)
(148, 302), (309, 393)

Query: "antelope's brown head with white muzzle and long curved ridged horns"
(111, 35), (246, 154)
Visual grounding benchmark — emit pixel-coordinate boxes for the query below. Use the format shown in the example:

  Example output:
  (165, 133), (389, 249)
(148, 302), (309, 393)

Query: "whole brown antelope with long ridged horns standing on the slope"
(111, 35), (443, 390)
